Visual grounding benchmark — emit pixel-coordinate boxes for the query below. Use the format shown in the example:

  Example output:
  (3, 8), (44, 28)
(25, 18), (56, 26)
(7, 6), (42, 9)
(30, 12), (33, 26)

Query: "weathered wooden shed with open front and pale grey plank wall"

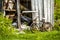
(3, 0), (54, 26)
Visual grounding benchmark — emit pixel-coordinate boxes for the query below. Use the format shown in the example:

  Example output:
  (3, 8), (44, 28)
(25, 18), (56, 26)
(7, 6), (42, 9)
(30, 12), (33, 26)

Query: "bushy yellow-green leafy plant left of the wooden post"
(0, 13), (15, 37)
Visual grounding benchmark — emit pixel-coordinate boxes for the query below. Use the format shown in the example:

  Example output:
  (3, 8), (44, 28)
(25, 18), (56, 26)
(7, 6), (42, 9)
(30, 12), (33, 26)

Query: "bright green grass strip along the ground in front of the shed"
(0, 31), (60, 40)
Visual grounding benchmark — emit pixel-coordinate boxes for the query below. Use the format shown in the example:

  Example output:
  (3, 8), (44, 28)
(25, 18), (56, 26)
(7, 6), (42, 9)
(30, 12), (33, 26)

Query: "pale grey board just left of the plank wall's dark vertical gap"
(37, 0), (44, 27)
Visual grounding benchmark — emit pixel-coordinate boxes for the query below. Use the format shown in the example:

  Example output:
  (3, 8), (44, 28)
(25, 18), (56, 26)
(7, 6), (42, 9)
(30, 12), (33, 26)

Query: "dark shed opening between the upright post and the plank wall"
(20, 0), (32, 25)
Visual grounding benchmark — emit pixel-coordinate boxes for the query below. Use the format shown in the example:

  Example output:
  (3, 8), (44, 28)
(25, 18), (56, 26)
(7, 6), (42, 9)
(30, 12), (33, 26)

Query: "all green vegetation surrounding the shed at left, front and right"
(0, 0), (60, 40)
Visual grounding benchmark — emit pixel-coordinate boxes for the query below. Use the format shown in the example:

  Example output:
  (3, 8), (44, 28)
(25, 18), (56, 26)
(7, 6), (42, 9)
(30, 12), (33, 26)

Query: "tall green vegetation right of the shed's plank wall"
(54, 0), (60, 31)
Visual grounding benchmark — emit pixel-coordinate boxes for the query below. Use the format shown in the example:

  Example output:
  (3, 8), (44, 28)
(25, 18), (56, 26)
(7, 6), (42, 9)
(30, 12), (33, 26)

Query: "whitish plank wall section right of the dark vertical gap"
(44, 0), (54, 24)
